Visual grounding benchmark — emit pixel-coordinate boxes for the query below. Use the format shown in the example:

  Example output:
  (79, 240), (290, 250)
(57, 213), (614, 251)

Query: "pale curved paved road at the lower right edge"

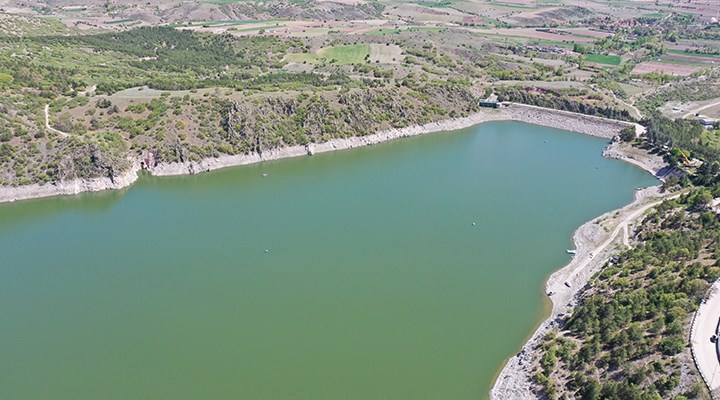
(690, 282), (720, 392)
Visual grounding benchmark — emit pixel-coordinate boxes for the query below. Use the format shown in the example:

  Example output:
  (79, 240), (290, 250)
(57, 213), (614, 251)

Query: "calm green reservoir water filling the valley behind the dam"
(0, 122), (657, 400)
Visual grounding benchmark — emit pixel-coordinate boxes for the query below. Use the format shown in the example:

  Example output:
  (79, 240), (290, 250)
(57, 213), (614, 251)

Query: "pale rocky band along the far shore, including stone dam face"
(0, 103), (629, 203)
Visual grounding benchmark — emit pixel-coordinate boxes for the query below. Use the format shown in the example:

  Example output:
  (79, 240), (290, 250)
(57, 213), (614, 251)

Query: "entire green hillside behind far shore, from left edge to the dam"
(0, 27), (478, 185)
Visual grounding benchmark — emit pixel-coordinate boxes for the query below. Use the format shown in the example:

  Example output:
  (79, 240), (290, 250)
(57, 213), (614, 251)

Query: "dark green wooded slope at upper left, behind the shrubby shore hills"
(0, 27), (295, 95)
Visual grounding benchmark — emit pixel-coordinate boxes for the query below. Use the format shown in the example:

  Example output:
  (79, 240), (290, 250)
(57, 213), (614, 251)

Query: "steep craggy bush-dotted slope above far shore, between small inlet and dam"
(118, 82), (478, 162)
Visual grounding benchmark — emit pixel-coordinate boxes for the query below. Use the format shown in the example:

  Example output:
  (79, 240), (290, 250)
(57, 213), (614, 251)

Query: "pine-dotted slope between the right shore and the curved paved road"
(536, 188), (720, 400)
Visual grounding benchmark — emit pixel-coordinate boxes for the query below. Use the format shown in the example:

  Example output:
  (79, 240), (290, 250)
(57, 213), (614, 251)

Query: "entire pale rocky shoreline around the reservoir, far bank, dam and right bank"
(0, 103), (664, 400)
